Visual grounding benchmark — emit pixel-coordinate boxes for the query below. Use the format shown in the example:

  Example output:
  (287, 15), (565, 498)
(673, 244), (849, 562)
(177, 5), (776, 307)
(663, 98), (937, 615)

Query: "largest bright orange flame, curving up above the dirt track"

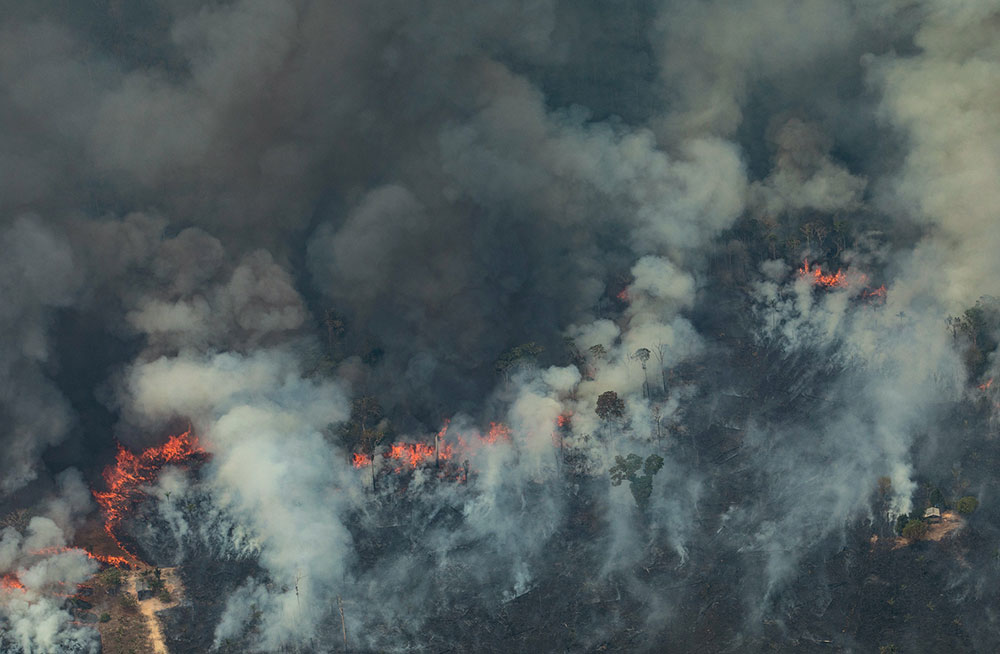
(90, 430), (206, 565)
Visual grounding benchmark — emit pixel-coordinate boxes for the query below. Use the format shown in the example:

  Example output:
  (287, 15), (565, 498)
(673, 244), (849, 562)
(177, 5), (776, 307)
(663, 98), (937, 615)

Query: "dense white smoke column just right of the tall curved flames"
(120, 349), (360, 649)
